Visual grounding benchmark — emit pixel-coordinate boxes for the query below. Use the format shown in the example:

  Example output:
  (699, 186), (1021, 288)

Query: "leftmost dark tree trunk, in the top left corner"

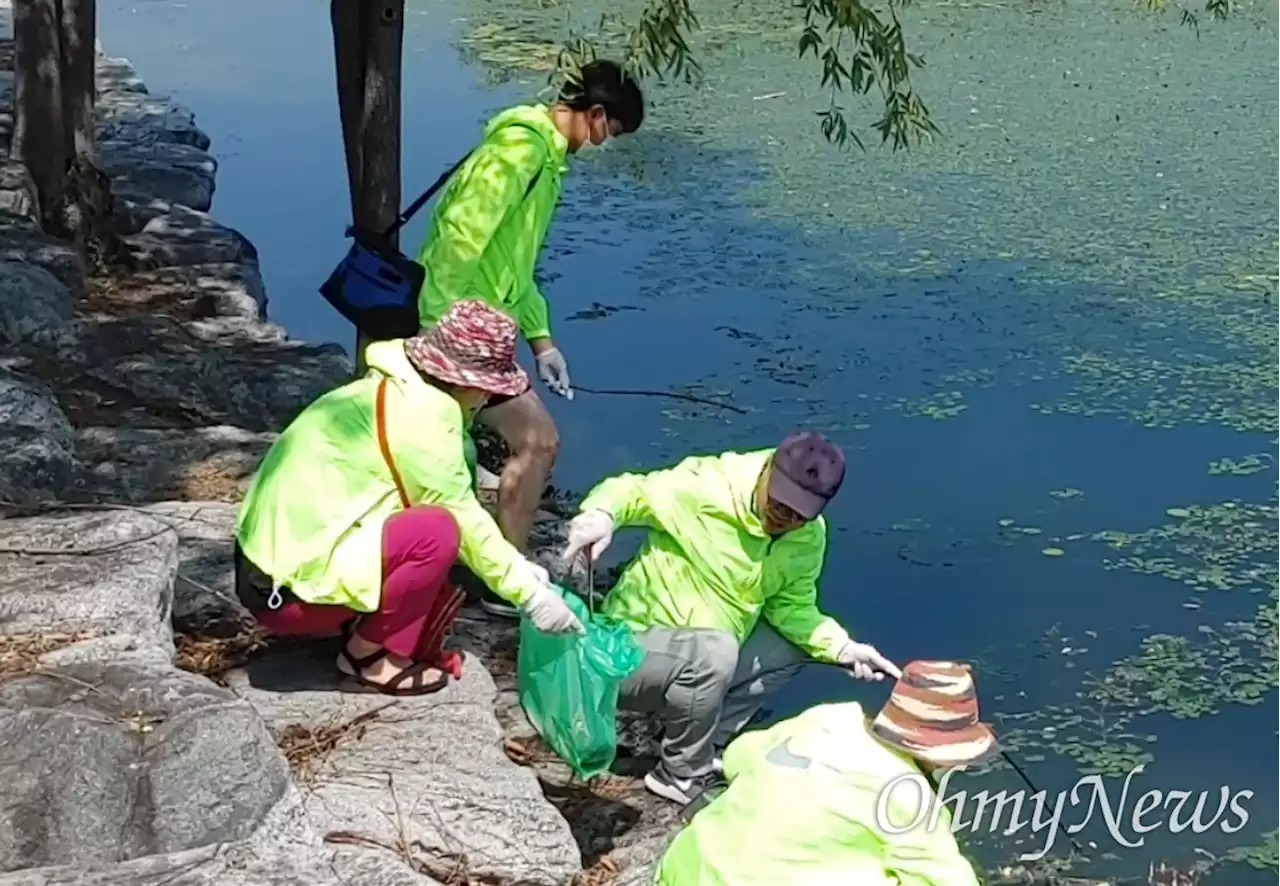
(10, 0), (72, 230)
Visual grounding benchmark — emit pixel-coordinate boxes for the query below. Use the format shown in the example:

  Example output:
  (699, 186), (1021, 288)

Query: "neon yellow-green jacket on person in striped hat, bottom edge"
(655, 702), (978, 886)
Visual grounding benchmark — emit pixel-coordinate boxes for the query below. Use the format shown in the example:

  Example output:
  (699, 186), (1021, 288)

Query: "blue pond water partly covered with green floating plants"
(102, 0), (1280, 886)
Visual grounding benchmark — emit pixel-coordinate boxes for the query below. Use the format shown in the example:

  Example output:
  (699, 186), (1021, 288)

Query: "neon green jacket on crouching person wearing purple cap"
(582, 449), (849, 662)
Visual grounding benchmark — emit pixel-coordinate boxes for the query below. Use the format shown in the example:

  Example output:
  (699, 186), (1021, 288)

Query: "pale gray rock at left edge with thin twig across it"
(0, 510), (178, 663)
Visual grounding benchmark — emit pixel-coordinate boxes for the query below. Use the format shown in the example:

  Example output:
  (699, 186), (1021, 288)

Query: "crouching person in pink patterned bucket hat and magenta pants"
(236, 301), (582, 695)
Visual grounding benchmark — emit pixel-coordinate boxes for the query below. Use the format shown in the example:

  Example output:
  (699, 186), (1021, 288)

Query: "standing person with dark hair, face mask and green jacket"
(417, 60), (644, 616)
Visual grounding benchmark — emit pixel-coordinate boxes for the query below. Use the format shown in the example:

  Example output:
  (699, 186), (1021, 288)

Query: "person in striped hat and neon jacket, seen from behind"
(654, 662), (998, 886)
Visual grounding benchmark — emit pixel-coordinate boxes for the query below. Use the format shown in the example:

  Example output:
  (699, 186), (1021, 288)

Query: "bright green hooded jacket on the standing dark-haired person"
(417, 105), (568, 339)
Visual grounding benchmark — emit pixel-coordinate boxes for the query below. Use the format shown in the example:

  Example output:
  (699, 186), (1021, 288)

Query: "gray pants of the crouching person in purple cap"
(618, 620), (806, 778)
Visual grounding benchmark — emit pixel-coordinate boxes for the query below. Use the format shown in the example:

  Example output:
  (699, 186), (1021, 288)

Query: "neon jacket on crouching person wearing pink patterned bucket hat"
(236, 339), (532, 612)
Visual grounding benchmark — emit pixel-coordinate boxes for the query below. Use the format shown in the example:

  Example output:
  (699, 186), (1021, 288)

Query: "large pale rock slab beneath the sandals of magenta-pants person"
(228, 643), (581, 886)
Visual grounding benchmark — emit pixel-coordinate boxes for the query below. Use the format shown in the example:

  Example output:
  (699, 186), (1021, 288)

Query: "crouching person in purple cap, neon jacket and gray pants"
(563, 431), (897, 804)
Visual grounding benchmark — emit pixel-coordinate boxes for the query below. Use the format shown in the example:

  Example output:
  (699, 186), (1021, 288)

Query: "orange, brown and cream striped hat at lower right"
(870, 662), (998, 766)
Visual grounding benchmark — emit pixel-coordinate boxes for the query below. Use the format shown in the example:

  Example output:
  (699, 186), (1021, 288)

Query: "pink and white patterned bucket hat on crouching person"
(404, 298), (529, 397)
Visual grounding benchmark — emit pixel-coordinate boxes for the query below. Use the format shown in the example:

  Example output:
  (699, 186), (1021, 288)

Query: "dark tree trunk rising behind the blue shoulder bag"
(329, 0), (404, 371)
